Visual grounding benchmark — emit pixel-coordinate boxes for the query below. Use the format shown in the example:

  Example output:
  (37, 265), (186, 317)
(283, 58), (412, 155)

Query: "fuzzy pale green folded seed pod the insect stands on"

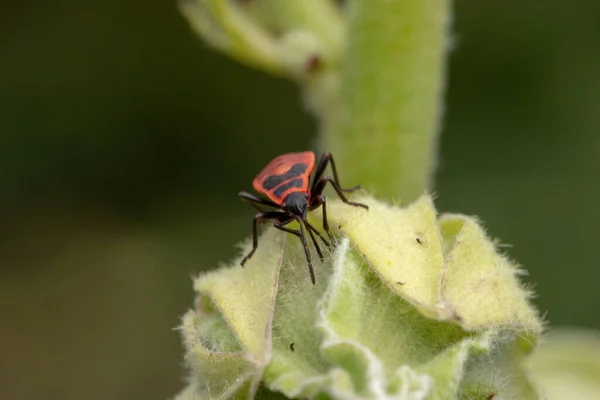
(175, 196), (541, 400)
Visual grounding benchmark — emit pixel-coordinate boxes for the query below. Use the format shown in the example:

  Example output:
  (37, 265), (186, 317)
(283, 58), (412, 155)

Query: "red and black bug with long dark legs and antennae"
(239, 151), (369, 284)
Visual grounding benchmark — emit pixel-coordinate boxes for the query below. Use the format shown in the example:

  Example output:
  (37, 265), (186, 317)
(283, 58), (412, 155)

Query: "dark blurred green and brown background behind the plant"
(0, 0), (600, 400)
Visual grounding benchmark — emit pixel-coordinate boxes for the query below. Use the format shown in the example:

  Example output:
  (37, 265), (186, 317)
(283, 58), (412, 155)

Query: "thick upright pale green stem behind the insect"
(313, 0), (450, 202)
